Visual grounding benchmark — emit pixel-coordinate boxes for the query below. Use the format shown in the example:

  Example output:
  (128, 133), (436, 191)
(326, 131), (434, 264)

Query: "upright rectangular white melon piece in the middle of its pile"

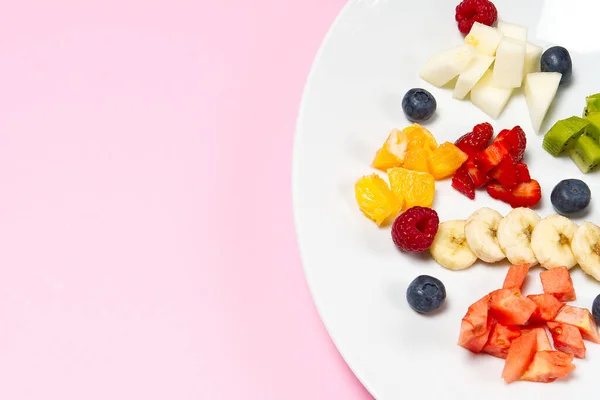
(493, 37), (525, 89)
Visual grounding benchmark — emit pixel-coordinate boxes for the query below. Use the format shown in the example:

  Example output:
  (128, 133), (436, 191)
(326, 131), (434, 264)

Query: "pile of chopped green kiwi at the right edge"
(542, 93), (600, 174)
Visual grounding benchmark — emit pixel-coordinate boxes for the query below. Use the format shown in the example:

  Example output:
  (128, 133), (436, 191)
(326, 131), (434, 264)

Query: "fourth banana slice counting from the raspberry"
(531, 214), (577, 269)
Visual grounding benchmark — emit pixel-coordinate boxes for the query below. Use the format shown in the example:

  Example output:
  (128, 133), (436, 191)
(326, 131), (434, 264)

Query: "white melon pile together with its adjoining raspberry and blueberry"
(419, 0), (573, 132)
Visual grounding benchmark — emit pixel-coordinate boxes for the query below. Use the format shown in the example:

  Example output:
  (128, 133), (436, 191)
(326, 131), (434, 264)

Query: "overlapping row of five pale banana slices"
(432, 207), (600, 281)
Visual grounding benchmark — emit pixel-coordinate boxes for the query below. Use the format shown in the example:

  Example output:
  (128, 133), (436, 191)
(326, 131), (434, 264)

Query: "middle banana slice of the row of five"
(497, 207), (541, 267)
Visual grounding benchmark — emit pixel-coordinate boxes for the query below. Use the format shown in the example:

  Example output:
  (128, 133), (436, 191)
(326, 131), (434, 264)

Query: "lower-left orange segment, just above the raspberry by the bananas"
(354, 174), (402, 225)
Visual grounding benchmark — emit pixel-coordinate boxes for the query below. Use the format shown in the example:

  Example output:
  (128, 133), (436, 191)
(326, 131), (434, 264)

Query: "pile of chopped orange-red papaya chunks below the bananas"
(458, 264), (600, 383)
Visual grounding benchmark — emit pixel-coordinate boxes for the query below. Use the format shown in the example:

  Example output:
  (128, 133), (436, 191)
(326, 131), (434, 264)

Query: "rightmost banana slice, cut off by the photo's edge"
(571, 222), (600, 281)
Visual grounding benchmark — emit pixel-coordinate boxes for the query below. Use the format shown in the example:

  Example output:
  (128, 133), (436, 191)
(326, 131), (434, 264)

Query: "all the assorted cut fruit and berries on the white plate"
(355, 0), (600, 383)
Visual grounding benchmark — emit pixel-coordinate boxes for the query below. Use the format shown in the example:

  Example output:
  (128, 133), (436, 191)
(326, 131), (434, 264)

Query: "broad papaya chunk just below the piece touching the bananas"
(490, 289), (536, 325)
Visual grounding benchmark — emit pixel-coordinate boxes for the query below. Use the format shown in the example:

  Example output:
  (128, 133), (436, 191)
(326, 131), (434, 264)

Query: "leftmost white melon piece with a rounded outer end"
(419, 44), (477, 87)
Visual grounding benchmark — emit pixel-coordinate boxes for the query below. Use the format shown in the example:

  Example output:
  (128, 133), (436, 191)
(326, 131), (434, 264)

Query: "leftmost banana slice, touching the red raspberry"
(429, 221), (477, 271)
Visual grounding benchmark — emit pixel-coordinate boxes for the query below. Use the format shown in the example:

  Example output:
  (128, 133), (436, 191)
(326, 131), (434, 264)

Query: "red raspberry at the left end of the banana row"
(392, 206), (440, 253)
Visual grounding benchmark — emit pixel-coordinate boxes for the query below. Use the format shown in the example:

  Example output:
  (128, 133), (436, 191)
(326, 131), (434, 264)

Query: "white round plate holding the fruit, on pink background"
(293, 0), (600, 400)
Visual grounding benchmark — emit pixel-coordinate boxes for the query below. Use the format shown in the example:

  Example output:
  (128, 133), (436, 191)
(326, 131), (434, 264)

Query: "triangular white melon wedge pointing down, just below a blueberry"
(523, 72), (562, 133)
